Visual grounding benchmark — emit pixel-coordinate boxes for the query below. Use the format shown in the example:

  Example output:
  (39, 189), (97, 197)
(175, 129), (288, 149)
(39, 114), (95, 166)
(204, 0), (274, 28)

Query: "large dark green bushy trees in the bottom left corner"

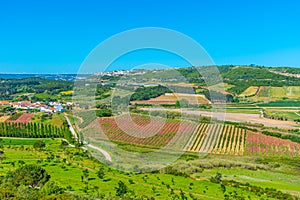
(0, 164), (93, 200)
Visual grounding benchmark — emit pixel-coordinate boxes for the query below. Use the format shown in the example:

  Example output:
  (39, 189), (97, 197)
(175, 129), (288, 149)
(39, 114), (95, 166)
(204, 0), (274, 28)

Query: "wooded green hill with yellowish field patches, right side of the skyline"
(123, 65), (300, 100)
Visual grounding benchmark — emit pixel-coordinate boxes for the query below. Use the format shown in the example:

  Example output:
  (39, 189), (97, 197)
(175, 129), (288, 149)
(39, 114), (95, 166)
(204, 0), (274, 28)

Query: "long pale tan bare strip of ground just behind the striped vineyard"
(142, 108), (299, 129)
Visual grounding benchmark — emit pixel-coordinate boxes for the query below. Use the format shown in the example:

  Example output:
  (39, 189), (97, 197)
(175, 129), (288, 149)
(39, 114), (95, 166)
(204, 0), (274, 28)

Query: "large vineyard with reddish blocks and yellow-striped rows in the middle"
(99, 115), (300, 157)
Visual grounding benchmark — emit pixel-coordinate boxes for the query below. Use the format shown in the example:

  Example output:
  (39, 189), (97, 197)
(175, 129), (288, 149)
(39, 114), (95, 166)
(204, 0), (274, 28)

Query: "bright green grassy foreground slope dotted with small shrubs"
(0, 139), (276, 199)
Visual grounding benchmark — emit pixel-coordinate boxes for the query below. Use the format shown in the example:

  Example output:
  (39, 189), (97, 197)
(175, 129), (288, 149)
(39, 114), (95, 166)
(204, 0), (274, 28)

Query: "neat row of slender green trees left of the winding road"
(0, 122), (72, 141)
